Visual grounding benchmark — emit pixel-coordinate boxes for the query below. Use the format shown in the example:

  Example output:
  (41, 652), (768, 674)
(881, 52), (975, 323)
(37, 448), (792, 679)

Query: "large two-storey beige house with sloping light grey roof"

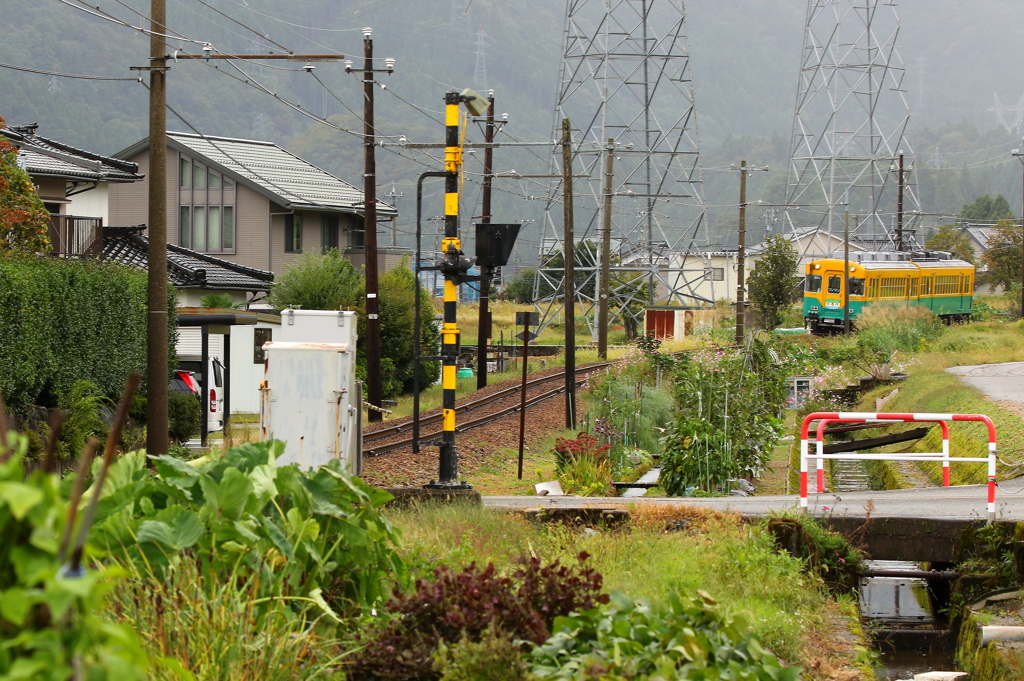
(111, 132), (406, 273)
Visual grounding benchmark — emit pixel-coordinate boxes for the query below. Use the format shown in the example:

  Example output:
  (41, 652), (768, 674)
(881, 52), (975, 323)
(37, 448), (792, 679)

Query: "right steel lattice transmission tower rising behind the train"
(785, 0), (921, 257)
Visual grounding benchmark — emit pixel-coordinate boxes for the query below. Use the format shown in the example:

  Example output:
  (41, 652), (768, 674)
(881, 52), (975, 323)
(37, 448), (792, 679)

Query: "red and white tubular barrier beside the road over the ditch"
(800, 412), (996, 522)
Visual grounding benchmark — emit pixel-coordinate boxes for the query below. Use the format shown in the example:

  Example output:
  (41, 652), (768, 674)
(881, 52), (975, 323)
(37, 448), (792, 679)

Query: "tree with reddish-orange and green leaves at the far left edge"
(0, 117), (51, 253)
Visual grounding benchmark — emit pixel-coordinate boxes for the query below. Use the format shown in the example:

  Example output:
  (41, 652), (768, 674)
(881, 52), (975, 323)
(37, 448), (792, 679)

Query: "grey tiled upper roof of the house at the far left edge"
(0, 124), (143, 182)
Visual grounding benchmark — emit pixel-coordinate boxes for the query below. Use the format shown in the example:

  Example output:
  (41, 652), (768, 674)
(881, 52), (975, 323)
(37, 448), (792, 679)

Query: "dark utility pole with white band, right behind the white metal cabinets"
(362, 29), (384, 422)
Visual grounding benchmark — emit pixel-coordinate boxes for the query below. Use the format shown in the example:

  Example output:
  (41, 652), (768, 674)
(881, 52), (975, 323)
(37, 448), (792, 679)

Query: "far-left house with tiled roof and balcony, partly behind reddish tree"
(0, 123), (143, 255)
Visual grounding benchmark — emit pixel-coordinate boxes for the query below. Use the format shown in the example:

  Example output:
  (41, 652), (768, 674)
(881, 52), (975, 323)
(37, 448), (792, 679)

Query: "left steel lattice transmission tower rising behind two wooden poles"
(535, 0), (714, 338)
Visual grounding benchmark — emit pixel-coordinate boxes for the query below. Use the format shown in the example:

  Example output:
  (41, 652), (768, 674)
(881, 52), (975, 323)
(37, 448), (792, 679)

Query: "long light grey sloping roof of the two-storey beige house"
(167, 132), (394, 215)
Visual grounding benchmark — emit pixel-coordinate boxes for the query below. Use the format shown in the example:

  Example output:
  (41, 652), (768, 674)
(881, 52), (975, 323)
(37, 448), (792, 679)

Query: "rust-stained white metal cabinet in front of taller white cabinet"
(260, 339), (362, 475)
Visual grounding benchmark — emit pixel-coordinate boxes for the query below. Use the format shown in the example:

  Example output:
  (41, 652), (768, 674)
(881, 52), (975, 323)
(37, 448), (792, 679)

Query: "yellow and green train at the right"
(804, 258), (974, 335)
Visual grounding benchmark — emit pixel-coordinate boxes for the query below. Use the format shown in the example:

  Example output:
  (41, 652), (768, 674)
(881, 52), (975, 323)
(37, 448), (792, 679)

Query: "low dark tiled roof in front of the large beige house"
(103, 225), (273, 291)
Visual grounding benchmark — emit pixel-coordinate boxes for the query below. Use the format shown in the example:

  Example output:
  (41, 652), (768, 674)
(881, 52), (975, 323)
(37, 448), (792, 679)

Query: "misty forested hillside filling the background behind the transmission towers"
(0, 0), (1024, 254)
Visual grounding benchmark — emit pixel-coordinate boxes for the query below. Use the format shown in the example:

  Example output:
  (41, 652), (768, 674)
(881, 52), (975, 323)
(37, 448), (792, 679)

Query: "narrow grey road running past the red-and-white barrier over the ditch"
(483, 477), (1024, 521)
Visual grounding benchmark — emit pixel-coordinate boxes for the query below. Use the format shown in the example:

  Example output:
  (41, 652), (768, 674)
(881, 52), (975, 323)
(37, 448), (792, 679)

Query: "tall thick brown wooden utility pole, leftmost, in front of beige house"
(145, 0), (168, 456)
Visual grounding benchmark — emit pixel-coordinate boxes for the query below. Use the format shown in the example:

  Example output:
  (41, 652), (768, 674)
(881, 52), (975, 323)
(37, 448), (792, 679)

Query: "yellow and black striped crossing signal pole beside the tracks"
(437, 90), (462, 486)
